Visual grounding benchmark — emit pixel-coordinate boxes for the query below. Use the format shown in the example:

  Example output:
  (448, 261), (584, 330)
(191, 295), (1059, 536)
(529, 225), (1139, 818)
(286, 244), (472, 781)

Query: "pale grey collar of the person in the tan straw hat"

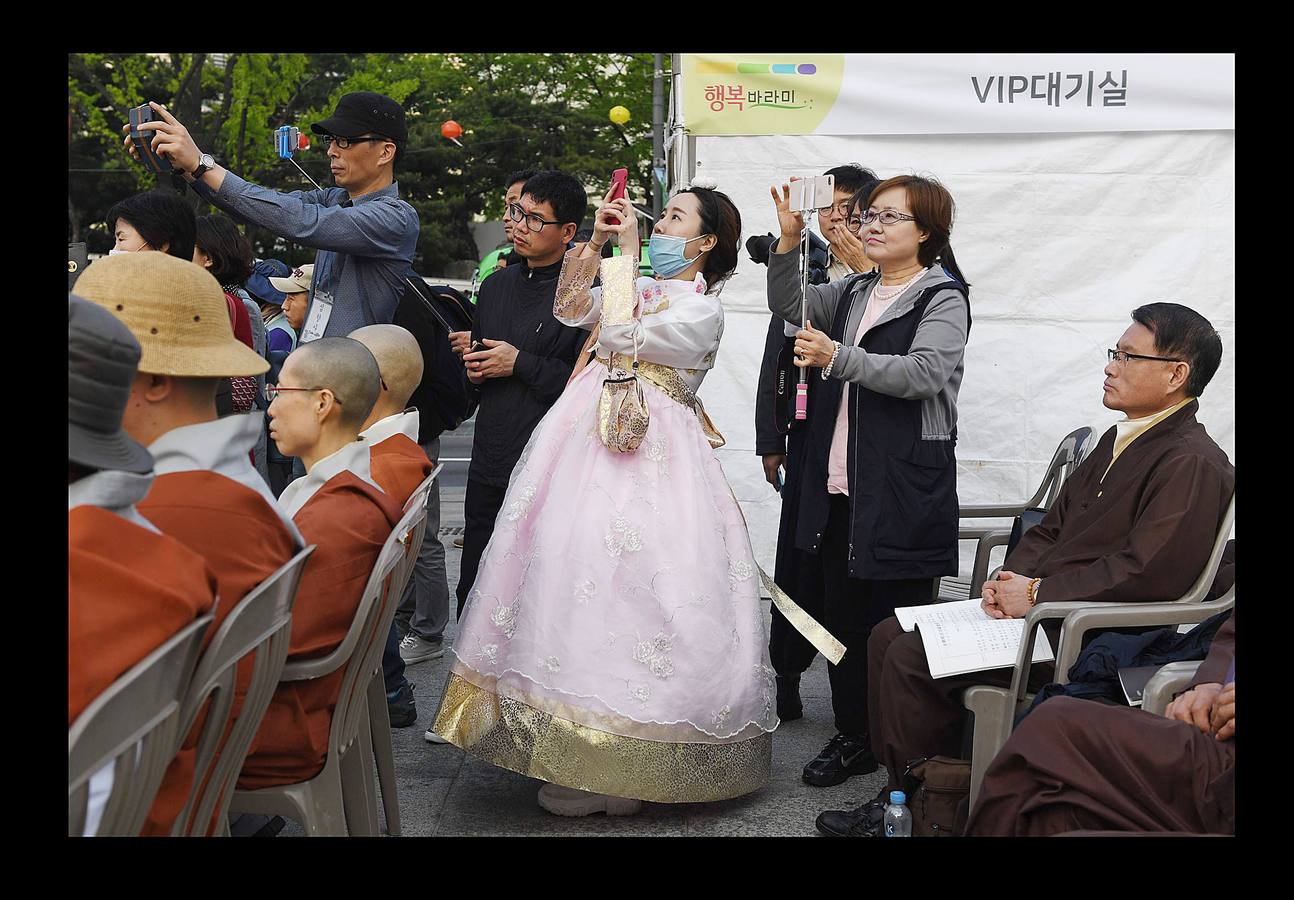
(149, 413), (305, 550)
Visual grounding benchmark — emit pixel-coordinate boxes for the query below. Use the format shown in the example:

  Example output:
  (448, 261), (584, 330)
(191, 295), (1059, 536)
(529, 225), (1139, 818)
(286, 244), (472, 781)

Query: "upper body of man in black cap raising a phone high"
(126, 91), (418, 343)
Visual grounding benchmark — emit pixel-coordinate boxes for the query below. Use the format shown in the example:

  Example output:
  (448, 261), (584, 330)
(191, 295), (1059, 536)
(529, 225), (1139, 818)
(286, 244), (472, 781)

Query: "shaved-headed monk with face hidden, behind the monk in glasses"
(351, 325), (439, 728)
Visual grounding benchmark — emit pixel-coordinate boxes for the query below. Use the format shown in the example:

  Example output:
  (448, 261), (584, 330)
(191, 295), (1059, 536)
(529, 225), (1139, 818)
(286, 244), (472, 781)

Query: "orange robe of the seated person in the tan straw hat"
(138, 471), (296, 835)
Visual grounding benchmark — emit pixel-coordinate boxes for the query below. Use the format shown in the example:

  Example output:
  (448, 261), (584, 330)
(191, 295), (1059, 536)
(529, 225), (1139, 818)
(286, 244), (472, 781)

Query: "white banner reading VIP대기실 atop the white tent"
(681, 52), (1236, 134)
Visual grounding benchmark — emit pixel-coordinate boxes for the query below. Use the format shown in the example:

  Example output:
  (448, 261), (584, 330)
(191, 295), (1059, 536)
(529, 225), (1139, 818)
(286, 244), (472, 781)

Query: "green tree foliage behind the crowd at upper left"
(67, 53), (668, 274)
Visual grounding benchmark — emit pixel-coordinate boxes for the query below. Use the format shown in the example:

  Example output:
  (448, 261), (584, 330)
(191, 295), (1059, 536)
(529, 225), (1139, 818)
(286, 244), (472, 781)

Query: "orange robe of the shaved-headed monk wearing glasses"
(238, 471), (401, 789)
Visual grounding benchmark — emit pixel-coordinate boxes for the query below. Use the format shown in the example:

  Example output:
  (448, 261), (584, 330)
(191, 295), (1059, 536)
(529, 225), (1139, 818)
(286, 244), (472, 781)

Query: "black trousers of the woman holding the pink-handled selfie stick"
(819, 494), (934, 734)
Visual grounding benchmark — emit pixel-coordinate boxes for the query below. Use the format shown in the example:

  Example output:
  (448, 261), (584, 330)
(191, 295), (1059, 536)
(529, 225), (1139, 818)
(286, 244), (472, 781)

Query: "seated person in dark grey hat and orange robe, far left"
(67, 295), (216, 834)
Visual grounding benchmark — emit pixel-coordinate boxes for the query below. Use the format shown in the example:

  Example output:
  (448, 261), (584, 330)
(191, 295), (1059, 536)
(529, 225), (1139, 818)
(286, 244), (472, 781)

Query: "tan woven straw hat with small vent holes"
(76, 252), (269, 378)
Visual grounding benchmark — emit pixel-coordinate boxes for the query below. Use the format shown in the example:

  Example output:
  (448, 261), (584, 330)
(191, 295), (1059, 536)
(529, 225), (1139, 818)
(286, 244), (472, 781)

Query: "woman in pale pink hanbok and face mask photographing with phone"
(433, 185), (778, 816)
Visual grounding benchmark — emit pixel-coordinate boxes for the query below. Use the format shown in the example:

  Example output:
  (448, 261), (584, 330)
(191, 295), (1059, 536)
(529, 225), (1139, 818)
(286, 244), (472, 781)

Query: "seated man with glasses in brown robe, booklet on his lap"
(818, 303), (1236, 835)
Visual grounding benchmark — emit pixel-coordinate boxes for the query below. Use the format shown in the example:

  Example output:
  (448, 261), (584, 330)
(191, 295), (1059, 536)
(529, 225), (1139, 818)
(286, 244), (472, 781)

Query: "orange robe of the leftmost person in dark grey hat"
(67, 506), (216, 727)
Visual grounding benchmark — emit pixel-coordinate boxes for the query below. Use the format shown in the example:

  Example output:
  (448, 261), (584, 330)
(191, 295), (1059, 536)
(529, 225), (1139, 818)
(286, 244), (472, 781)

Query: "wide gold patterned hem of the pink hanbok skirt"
(432, 674), (773, 803)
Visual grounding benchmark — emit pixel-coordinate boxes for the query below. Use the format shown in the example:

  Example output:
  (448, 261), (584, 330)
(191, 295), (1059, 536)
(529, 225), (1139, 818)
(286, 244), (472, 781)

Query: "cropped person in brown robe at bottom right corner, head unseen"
(967, 610), (1236, 835)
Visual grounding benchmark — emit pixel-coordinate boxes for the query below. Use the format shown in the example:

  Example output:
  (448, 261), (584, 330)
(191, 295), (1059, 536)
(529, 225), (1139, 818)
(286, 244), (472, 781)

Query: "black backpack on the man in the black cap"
(395, 269), (477, 444)
